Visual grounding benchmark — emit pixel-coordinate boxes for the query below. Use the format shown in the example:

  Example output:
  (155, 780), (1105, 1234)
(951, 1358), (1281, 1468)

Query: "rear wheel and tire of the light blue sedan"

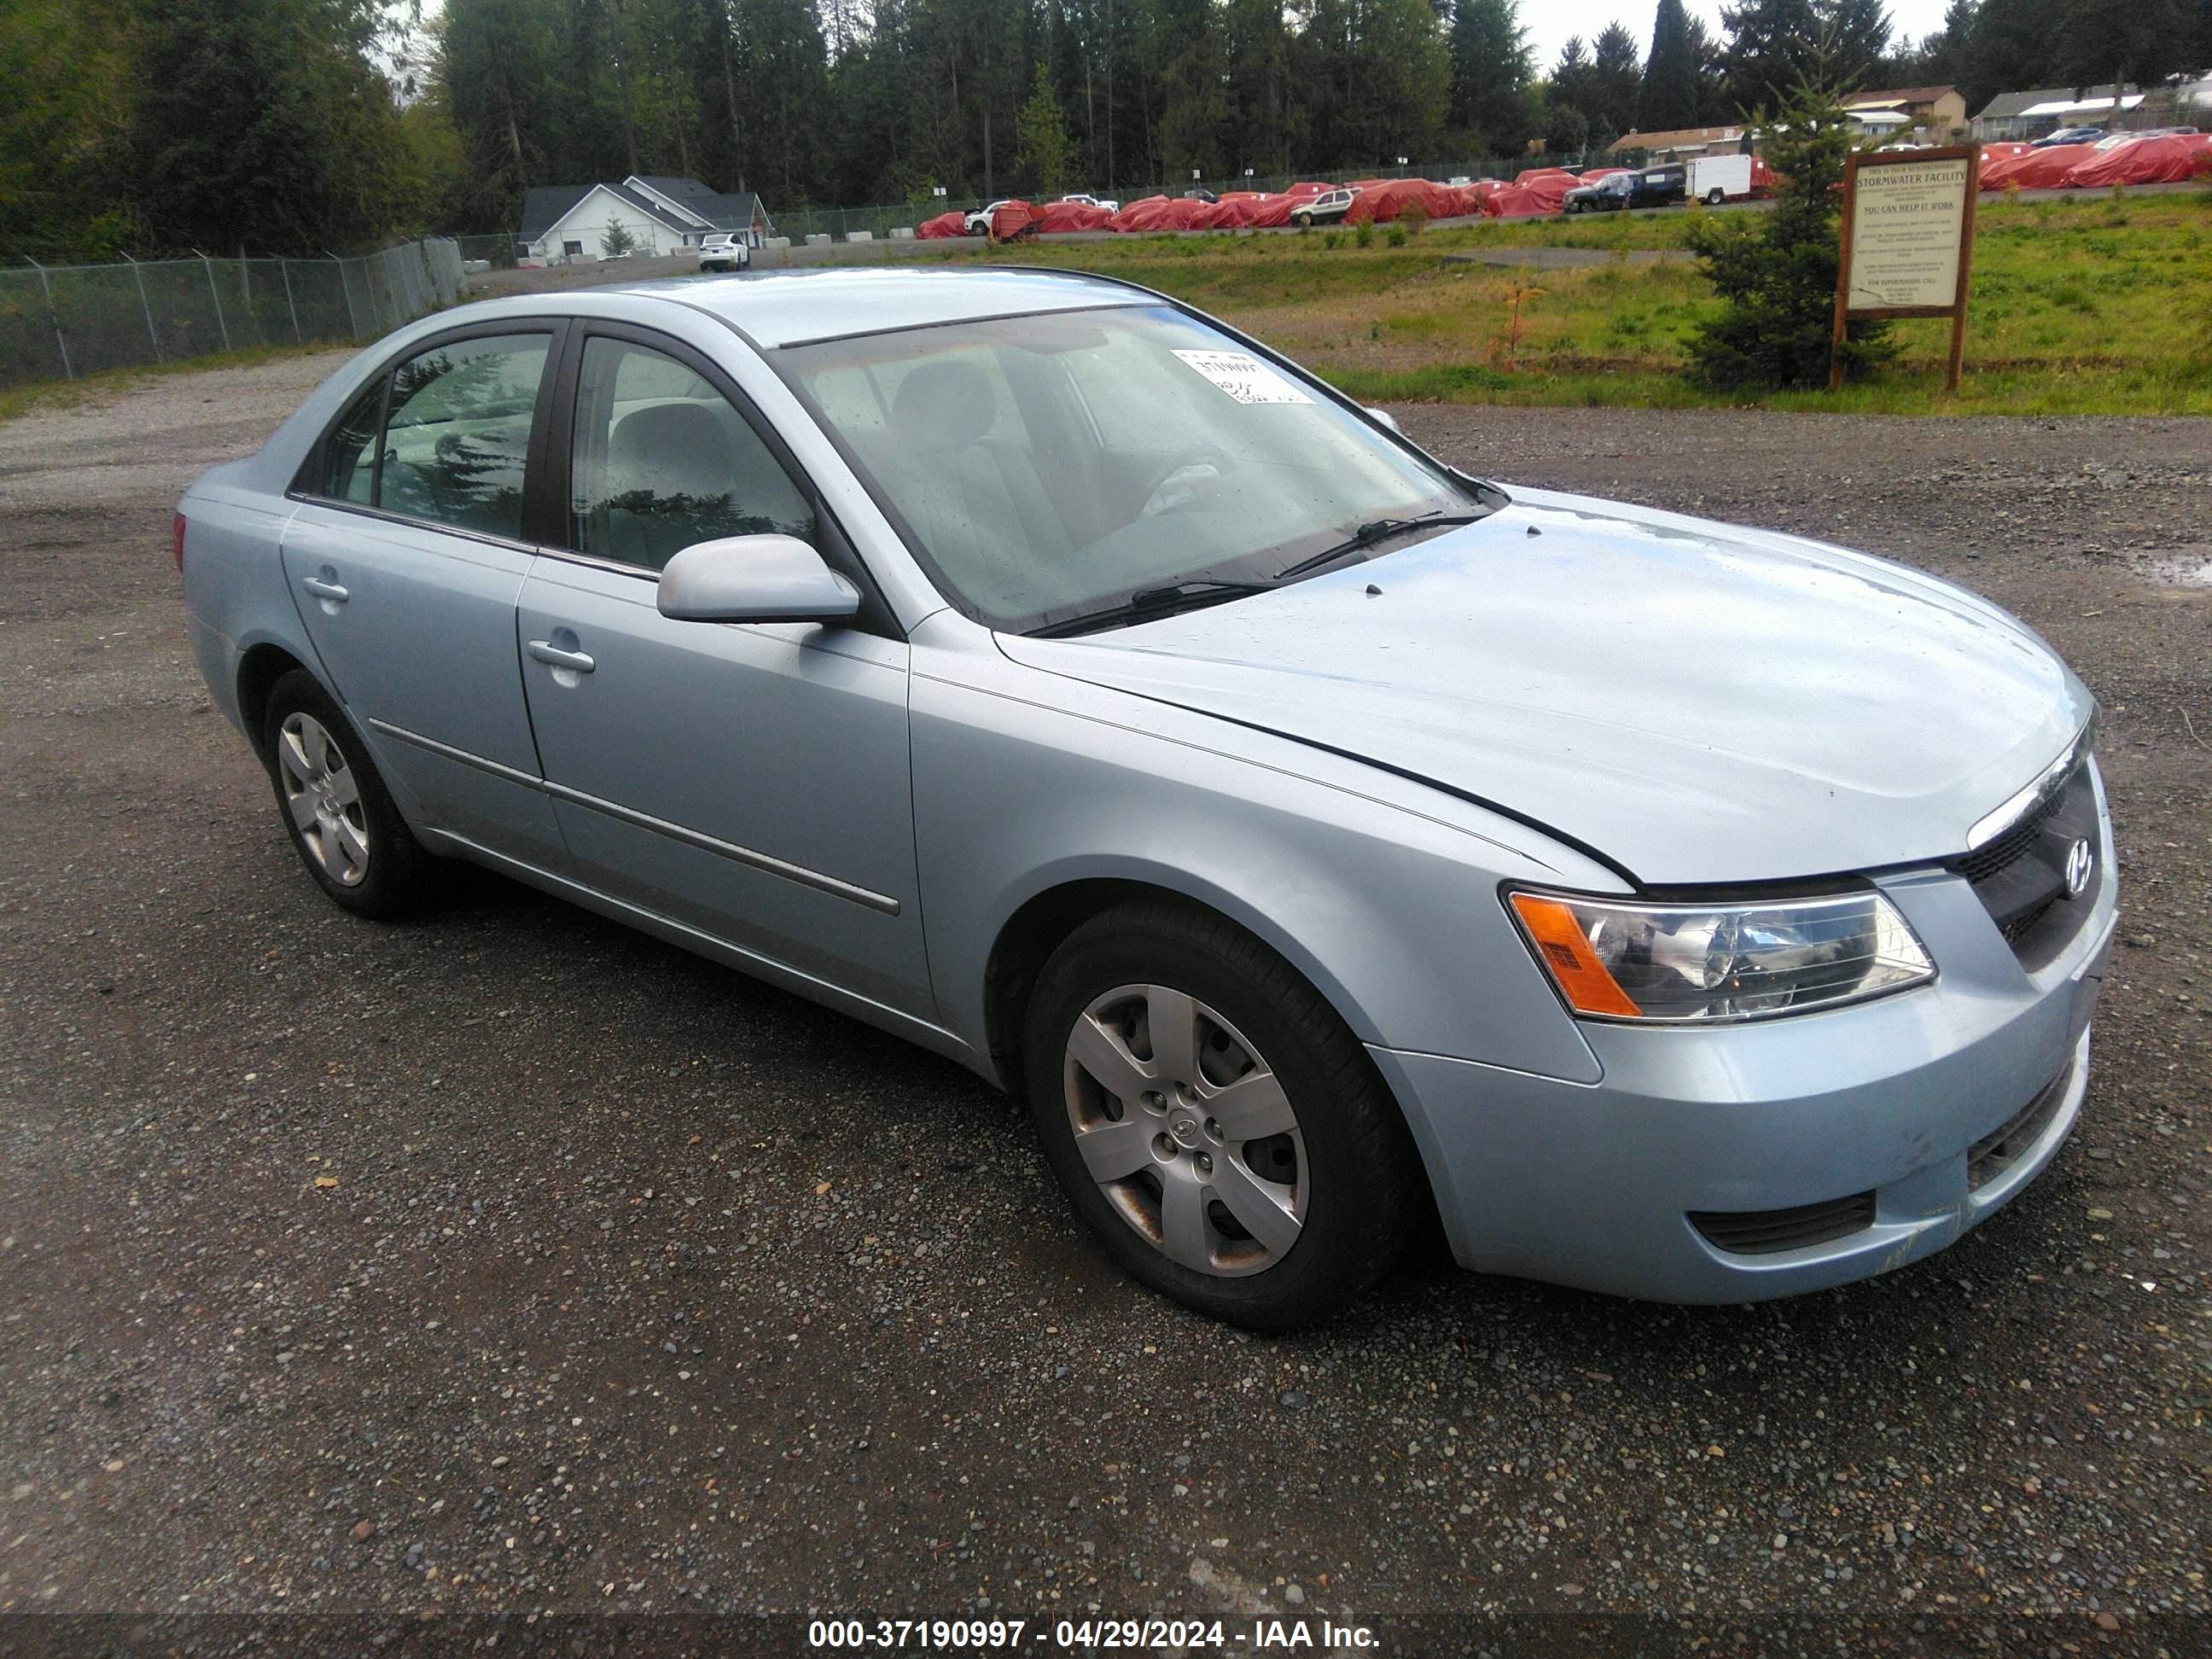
(261, 668), (434, 920)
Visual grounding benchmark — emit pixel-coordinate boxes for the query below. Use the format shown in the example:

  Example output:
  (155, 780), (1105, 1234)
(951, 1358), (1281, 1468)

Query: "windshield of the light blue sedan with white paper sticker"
(778, 306), (1487, 631)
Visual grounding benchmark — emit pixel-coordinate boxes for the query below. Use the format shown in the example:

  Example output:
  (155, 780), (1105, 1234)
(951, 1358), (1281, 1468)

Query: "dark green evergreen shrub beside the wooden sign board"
(1688, 86), (1895, 392)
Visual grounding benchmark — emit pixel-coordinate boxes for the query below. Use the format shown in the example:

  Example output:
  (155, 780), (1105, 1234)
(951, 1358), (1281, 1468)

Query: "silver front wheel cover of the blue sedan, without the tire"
(1064, 984), (1309, 1278)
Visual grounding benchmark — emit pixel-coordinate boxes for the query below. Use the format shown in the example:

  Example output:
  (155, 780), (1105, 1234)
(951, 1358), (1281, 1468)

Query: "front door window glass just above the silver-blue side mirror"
(571, 339), (814, 571)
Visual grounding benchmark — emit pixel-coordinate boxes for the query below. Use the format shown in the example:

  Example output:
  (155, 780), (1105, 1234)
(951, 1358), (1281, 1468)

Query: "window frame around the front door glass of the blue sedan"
(539, 317), (907, 642)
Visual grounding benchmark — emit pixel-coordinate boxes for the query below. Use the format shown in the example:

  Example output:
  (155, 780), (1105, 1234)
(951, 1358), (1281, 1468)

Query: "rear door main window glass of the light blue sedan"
(376, 334), (550, 539)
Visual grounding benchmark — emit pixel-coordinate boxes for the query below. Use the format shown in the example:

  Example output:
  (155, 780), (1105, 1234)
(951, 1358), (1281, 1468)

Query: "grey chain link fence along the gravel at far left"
(0, 236), (463, 385)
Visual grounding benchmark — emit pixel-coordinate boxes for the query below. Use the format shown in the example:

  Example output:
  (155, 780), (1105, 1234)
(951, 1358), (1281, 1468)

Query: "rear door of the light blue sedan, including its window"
(283, 321), (562, 867)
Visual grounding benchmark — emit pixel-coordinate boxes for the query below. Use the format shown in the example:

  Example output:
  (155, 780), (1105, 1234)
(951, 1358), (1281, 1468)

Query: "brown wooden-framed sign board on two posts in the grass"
(1827, 143), (1982, 392)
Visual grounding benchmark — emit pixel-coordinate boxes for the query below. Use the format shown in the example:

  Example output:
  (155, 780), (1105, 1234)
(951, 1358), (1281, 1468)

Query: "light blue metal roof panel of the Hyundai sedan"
(597, 265), (1157, 350)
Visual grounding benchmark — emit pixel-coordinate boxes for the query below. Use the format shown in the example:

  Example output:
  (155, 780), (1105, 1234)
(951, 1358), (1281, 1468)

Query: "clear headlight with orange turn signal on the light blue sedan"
(1509, 894), (1936, 1022)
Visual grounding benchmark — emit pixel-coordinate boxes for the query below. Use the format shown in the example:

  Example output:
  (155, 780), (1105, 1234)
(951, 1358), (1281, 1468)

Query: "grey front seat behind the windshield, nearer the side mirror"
(892, 358), (1073, 597)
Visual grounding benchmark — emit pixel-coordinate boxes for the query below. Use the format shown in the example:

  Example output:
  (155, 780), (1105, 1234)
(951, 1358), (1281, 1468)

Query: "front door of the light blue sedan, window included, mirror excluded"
(518, 323), (934, 1020)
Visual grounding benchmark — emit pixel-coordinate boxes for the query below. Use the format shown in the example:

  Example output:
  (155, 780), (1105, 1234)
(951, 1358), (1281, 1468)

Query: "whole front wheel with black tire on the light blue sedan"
(1022, 900), (1427, 1330)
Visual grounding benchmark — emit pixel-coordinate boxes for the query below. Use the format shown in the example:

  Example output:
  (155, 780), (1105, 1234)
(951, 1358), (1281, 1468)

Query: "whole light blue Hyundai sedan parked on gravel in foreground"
(175, 268), (2117, 1327)
